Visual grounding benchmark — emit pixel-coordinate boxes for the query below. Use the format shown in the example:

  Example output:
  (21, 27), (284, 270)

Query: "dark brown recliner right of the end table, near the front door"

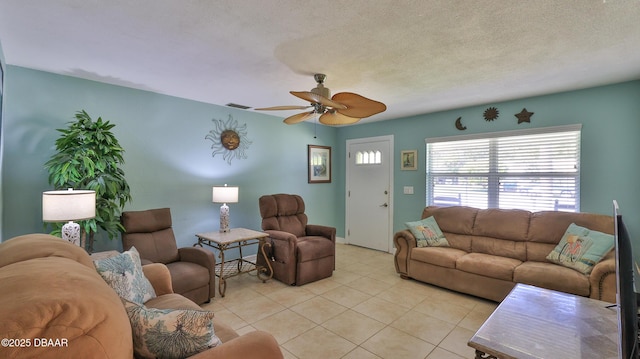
(258, 194), (336, 285)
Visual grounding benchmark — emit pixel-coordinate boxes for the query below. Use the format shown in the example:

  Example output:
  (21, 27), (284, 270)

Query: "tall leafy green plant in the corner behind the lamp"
(45, 110), (131, 253)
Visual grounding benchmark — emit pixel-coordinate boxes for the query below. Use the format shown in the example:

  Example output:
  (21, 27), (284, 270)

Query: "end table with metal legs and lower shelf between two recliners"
(194, 228), (273, 297)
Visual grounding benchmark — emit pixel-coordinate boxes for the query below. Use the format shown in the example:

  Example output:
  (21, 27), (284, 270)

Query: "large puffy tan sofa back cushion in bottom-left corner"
(0, 256), (133, 359)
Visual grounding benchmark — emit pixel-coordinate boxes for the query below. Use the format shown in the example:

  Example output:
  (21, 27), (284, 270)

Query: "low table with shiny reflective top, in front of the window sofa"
(468, 284), (618, 359)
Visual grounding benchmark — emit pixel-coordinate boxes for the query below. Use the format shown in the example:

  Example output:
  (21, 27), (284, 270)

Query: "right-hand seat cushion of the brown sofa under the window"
(513, 261), (591, 297)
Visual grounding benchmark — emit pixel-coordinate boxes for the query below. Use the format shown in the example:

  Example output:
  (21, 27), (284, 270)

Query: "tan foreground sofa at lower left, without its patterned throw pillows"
(0, 234), (282, 359)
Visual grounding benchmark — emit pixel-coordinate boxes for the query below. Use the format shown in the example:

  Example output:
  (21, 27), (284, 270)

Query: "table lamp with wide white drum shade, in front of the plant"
(42, 188), (96, 246)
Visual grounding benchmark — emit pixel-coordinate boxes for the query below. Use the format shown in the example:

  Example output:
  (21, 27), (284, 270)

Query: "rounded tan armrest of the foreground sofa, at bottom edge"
(190, 331), (284, 359)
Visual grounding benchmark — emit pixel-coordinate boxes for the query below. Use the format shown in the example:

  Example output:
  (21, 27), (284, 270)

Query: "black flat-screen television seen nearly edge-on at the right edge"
(613, 201), (638, 359)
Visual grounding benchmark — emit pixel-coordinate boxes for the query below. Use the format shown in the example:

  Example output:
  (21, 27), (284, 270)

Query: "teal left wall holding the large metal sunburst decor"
(2, 66), (344, 250)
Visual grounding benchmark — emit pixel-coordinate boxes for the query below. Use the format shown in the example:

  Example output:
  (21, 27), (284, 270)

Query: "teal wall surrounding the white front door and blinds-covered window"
(336, 81), (640, 255)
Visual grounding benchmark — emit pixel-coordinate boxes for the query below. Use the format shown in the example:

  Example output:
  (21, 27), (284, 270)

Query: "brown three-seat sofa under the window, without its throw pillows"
(393, 206), (616, 302)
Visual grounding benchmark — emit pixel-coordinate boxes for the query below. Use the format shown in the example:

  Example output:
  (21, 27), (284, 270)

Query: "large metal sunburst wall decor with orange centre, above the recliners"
(204, 115), (251, 165)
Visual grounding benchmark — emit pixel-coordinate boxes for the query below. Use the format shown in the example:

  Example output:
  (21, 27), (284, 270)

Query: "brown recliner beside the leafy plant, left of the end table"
(120, 208), (216, 304)
